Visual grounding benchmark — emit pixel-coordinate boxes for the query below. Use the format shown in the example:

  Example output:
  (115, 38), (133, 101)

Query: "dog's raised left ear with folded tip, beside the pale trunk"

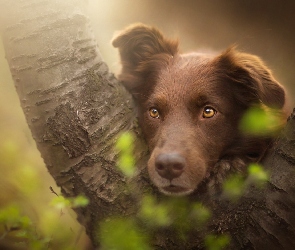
(112, 24), (178, 90)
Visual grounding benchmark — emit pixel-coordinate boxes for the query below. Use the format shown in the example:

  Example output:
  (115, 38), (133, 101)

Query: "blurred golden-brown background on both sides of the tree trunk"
(0, 0), (295, 249)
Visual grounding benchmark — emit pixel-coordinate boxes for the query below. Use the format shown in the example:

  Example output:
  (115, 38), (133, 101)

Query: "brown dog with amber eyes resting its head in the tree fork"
(113, 24), (285, 195)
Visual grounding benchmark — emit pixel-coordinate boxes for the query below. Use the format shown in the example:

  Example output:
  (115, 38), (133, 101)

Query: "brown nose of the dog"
(155, 153), (185, 180)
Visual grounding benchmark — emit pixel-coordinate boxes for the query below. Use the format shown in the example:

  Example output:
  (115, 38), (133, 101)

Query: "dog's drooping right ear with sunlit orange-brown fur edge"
(218, 48), (285, 109)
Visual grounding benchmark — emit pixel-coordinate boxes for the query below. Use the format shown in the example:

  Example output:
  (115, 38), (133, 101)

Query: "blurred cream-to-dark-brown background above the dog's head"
(89, 0), (295, 103)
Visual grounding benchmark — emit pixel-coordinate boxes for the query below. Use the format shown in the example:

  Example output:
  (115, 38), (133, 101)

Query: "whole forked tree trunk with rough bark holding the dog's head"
(1, 0), (295, 249)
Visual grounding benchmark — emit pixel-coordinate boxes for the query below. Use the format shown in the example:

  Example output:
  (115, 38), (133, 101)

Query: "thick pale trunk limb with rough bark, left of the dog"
(1, 0), (147, 246)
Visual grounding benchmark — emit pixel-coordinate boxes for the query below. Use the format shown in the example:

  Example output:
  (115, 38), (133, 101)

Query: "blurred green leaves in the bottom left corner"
(0, 188), (88, 250)
